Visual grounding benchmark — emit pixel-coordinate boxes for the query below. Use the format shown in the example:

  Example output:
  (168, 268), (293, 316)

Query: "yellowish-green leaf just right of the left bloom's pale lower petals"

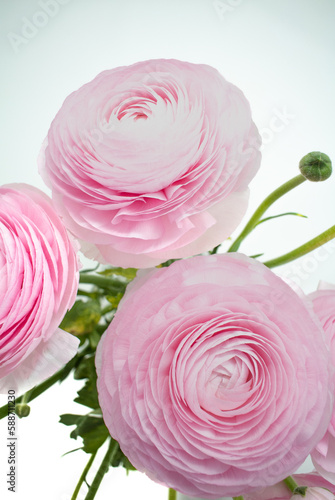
(60, 300), (101, 335)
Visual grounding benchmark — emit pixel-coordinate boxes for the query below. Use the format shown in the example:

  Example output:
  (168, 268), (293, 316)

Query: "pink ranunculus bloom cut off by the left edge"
(0, 184), (79, 393)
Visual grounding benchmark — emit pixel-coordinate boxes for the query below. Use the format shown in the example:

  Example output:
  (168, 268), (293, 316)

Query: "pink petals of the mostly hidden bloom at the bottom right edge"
(244, 471), (335, 500)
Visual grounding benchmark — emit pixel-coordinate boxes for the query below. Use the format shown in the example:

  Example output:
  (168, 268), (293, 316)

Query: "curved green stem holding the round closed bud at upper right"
(227, 174), (306, 252)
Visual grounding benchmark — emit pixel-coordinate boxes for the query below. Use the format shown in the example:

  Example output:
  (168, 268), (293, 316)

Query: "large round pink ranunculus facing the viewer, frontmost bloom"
(96, 254), (334, 499)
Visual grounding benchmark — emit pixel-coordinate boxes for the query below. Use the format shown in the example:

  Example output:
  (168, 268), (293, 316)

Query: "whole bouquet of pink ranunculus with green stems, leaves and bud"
(0, 59), (335, 500)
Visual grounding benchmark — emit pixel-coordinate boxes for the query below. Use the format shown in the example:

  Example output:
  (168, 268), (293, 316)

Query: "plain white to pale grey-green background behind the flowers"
(0, 0), (335, 500)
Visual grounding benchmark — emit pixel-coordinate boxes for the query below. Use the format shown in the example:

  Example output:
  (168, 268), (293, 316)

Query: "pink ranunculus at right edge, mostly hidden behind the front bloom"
(310, 283), (335, 484)
